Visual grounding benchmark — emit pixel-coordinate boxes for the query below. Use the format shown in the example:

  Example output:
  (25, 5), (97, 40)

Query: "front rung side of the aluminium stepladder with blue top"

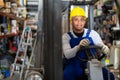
(11, 27), (32, 80)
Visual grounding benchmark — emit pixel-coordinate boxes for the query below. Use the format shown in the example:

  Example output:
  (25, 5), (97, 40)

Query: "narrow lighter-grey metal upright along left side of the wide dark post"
(34, 0), (44, 68)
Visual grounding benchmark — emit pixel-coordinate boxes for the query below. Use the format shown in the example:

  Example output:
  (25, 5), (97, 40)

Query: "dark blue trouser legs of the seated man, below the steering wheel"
(63, 64), (115, 80)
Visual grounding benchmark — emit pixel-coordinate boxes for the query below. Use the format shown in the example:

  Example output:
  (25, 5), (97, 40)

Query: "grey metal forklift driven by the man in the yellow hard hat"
(6, 0), (120, 80)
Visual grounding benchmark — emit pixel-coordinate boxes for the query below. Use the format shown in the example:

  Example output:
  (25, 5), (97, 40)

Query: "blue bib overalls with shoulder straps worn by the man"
(63, 30), (93, 80)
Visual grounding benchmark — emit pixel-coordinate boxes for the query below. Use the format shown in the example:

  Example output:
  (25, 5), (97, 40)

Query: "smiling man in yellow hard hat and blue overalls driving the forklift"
(62, 6), (114, 80)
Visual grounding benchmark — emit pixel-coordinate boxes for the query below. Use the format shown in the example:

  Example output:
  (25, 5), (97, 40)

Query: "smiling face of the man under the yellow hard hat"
(71, 16), (86, 33)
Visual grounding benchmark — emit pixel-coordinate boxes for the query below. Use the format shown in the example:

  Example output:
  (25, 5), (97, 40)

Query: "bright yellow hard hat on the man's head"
(70, 6), (86, 20)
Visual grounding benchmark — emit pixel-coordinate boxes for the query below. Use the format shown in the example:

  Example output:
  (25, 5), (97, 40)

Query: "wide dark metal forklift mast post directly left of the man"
(43, 0), (63, 80)
